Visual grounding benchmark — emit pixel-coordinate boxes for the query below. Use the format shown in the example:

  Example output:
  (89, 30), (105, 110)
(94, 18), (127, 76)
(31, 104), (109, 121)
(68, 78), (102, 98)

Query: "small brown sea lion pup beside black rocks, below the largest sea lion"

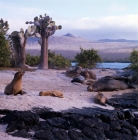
(94, 92), (107, 106)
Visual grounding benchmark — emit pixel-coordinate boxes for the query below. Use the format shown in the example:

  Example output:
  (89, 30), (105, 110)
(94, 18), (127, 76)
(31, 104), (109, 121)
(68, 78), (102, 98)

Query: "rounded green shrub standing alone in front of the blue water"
(75, 48), (101, 68)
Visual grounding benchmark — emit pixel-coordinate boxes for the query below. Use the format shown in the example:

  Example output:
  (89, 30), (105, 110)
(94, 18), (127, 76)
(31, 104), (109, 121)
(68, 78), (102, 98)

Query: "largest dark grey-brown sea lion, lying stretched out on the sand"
(87, 77), (134, 91)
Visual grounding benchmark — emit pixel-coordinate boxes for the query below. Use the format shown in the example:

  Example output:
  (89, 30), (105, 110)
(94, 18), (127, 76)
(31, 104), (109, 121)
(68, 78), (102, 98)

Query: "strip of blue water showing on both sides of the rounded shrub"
(71, 62), (131, 69)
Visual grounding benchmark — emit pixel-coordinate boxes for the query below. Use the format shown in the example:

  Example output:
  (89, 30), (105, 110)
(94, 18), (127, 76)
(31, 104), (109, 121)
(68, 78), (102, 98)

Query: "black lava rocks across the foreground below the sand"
(0, 90), (138, 140)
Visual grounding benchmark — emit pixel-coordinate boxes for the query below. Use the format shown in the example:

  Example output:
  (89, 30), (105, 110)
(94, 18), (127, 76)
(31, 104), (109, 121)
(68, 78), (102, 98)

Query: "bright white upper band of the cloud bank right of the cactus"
(57, 15), (138, 30)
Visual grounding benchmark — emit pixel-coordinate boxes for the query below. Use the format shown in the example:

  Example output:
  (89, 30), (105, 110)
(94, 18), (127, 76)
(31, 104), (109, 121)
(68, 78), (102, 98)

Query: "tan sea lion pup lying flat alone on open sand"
(39, 90), (64, 98)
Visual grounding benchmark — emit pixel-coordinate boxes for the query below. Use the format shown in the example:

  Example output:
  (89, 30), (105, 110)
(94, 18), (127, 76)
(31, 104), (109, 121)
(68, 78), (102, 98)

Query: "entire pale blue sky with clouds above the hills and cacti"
(0, 0), (138, 40)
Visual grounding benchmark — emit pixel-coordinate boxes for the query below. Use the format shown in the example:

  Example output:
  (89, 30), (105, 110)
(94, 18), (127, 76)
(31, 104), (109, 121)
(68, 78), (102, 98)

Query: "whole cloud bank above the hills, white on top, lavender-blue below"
(56, 15), (138, 40)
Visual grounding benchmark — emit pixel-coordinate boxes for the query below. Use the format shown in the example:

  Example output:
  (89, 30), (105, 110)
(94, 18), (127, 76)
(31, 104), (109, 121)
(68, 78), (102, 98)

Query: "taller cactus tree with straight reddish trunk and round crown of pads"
(26, 14), (62, 70)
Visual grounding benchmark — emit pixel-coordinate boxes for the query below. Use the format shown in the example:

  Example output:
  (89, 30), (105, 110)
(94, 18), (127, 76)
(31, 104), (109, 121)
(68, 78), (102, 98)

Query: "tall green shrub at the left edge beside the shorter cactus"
(0, 32), (11, 67)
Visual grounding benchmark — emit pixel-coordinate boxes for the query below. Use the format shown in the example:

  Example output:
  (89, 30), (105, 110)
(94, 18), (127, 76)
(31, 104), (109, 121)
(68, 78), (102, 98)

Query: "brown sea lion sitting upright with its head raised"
(4, 71), (25, 95)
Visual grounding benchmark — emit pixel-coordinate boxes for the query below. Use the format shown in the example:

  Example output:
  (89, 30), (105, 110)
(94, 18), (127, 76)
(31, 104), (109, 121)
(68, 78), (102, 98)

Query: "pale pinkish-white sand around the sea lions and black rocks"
(0, 69), (135, 140)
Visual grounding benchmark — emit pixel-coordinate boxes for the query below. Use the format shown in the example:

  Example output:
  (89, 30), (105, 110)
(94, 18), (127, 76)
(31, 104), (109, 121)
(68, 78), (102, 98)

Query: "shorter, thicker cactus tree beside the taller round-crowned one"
(11, 26), (36, 68)
